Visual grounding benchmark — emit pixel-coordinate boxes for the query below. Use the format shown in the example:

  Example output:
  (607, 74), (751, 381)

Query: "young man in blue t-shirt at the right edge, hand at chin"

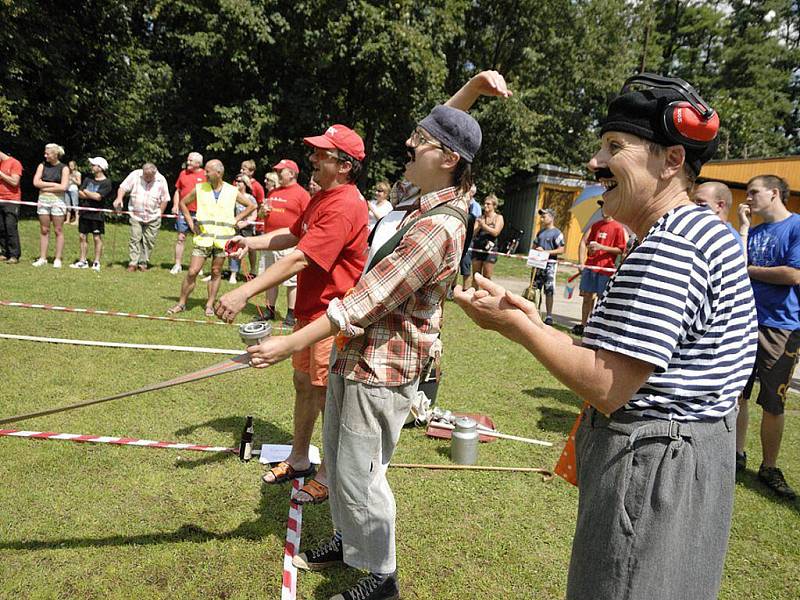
(736, 175), (800, 499)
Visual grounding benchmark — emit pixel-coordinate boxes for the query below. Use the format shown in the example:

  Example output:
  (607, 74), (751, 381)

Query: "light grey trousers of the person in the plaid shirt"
(322, 373), (419, 573)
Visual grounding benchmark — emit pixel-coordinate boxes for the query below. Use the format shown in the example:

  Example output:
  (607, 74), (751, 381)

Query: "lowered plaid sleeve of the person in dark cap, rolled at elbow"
(342, 215), (463, 328)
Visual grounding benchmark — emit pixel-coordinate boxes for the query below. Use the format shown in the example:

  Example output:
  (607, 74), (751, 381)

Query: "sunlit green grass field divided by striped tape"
(0, 221), (800, 600)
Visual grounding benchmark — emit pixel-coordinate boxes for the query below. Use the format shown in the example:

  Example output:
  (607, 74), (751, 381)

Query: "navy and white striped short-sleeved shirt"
(583, 206), (758, 421)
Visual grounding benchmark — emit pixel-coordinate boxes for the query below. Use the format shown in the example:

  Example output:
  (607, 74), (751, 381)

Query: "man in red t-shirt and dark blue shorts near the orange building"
(572, 200), (628, 335)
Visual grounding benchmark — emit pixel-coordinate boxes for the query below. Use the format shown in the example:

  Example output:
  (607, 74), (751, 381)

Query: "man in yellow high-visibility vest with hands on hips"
(167, 159), (256, 317)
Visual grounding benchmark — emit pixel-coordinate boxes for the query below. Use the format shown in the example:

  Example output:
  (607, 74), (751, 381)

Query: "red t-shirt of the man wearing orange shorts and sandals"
(289, 183), (367, 321)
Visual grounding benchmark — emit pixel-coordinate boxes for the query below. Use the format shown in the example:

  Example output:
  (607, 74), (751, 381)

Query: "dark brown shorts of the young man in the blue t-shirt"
(742, 325), (800, 415)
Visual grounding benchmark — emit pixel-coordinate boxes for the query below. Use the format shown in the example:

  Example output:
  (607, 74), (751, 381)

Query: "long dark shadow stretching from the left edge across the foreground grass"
(0, 485), (318, 550)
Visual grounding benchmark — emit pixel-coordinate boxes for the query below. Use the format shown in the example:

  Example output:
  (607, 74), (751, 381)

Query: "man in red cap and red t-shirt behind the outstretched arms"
(261, 158), (311, 327)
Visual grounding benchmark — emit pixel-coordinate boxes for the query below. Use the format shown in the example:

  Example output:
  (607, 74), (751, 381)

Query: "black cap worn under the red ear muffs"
(600, 88), (719, 175)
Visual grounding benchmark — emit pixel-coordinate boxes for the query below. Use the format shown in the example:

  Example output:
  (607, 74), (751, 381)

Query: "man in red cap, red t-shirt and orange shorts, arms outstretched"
(216, 125), (368, 500)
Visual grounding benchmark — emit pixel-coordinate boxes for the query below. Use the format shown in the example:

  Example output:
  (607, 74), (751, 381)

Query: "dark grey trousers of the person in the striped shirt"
(567, 408), (736, 600)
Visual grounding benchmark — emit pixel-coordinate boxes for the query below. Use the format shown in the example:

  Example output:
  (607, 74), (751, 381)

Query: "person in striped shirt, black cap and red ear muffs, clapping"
(455, 74), (757, 600)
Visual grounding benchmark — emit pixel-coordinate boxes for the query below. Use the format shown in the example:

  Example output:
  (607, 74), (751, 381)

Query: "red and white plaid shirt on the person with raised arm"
(331, 187), (467, 386)
